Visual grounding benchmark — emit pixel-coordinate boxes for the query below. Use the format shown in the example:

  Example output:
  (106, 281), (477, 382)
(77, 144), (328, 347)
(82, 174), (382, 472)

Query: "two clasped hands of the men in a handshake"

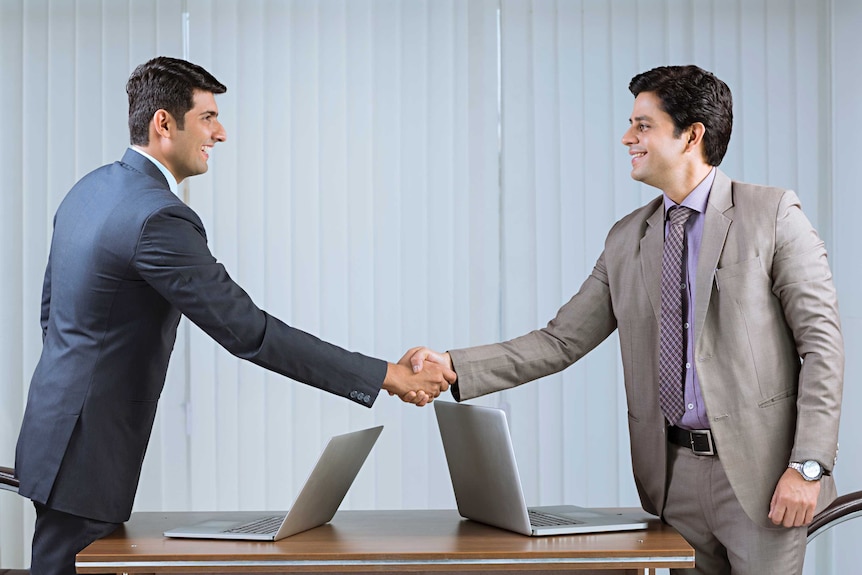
(383, 347), (458, 407)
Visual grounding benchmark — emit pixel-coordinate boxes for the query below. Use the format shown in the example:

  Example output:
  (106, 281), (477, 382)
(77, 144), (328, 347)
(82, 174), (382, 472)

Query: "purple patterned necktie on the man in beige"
(658, 206), (694, 425)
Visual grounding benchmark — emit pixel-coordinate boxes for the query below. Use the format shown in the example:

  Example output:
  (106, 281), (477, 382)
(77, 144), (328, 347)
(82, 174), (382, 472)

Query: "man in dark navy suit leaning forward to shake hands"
(15, 57), (454, 575)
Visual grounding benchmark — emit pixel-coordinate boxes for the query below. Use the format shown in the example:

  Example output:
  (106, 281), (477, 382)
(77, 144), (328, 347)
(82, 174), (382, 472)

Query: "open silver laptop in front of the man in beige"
(434, 401), (651, 536)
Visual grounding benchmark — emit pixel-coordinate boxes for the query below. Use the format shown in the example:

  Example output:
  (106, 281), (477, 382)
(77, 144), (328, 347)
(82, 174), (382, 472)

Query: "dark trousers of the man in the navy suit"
(30, 501), (122, 575)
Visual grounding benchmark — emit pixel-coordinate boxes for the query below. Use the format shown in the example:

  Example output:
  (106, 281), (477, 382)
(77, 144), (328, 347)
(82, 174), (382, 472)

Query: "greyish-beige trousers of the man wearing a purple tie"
(664, 445), (807, 575)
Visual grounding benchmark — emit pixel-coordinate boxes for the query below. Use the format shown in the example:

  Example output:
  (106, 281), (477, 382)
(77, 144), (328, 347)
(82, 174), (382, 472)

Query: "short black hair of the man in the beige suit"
(629, 66), (733, 166)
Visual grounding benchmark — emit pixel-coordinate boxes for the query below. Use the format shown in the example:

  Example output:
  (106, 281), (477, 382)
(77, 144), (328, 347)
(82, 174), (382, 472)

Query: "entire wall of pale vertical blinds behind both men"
(0, 0), (862, 573)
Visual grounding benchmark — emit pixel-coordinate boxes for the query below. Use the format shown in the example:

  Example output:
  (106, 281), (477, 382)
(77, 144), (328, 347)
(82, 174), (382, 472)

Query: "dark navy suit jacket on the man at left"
(15, 150), (386, 522)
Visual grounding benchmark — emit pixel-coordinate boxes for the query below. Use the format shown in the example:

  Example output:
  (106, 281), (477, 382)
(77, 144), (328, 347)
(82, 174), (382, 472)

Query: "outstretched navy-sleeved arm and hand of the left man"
(135, 206), (448, 407)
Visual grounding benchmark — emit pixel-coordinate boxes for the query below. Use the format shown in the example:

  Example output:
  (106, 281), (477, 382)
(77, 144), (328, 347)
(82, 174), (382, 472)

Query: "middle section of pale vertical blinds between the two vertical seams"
(154, 1), (499, 509)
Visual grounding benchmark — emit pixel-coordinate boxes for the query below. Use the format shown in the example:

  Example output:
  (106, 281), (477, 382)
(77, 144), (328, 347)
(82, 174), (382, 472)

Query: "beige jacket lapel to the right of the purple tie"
(694, 169), (733, 338)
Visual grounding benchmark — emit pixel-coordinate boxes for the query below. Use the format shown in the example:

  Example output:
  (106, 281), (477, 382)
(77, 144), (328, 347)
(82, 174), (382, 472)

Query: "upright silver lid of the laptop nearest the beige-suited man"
(434, 400), (532, 535)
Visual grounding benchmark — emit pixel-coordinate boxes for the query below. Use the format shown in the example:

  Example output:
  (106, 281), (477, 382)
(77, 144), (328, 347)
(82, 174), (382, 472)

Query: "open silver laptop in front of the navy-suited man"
(165, 425), (383, 541)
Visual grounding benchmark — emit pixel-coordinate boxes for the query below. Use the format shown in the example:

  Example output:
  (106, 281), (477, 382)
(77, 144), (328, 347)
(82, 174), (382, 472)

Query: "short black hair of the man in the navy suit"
(126, 56), (227, 146)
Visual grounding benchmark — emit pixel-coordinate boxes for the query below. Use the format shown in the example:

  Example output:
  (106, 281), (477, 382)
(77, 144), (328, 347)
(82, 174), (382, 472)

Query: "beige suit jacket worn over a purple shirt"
(451, 171), (844, 526)
